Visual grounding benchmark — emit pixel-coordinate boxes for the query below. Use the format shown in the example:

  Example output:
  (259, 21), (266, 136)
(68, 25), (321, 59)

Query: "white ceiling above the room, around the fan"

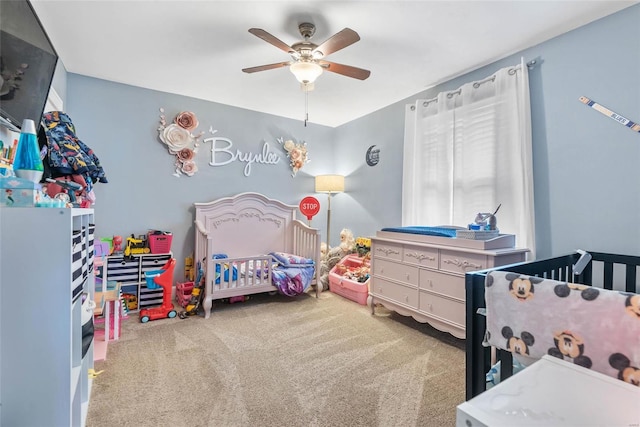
(31, 0), (638, 126)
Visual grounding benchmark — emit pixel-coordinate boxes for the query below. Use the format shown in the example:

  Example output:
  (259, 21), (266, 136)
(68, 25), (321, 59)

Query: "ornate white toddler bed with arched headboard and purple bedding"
(194, 193), (321, 318)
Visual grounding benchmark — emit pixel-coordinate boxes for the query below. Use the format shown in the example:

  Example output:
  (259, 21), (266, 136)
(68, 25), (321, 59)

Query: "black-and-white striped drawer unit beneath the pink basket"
(103, 252), (173, 310)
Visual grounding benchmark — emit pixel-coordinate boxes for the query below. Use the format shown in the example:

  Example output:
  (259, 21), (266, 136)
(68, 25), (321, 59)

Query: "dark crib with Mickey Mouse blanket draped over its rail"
(465, 251), (640, 400)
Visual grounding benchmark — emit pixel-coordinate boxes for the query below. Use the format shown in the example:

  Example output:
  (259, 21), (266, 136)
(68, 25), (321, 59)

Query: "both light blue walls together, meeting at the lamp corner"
(56, 5), (640, 272)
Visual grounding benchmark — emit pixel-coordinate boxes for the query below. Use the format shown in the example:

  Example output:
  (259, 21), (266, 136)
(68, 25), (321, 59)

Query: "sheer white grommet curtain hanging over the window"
(402, 58), (535, 259)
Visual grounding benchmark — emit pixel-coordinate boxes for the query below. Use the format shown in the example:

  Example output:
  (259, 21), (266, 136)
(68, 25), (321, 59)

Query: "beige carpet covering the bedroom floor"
(87, 292), (465, 427)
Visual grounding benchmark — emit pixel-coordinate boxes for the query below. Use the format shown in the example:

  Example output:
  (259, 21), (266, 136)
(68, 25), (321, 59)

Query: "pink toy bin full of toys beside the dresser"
(329, 255), (371, 305)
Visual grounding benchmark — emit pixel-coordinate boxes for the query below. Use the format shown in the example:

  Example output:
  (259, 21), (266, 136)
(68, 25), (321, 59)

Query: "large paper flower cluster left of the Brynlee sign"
(158, 108), (204, 177)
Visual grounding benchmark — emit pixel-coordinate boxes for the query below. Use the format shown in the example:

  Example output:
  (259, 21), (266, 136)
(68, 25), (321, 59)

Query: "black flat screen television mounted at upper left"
(0, 0), (58, 132)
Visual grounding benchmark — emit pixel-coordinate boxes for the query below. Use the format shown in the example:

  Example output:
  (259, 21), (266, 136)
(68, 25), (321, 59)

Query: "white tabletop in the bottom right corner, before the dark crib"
(456, 355), (640, 427)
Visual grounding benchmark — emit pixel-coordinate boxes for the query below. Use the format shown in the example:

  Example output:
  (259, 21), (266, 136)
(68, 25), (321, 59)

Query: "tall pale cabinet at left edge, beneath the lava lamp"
(0, 208), (94, 427)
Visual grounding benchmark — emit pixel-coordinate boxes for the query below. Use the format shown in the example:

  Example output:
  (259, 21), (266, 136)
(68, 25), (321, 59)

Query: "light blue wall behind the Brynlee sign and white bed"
(65, 73), (337, 268)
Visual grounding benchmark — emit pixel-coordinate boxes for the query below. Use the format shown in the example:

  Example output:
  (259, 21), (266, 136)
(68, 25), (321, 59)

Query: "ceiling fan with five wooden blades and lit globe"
(242, 22), (371, 90)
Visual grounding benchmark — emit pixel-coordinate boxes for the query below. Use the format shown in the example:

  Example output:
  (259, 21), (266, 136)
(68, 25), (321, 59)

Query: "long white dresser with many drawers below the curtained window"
(368, 231), (528, 339)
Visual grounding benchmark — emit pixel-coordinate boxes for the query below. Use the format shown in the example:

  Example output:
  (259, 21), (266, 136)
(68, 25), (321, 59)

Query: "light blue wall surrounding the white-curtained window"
(332, 5), (640, 258)
